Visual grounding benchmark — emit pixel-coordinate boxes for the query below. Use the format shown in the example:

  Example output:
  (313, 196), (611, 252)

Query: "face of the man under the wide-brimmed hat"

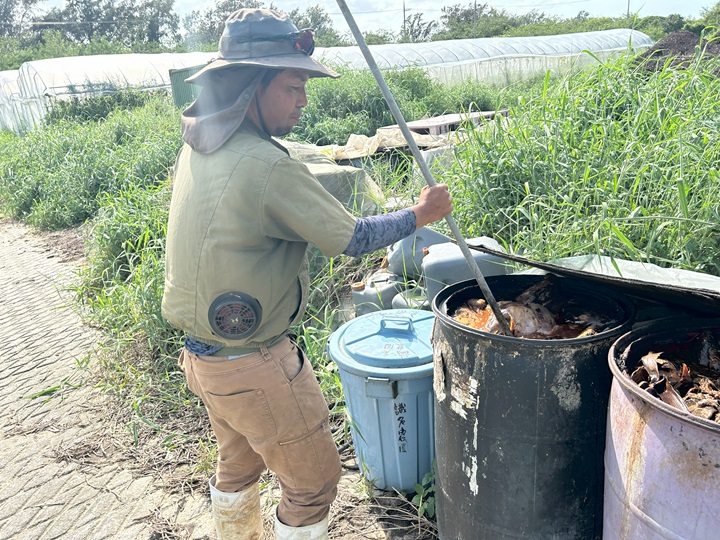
(255, 69), (309, 137)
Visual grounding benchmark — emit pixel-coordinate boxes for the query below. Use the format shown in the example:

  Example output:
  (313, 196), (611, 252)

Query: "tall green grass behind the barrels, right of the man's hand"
(442, 52), (720, 274)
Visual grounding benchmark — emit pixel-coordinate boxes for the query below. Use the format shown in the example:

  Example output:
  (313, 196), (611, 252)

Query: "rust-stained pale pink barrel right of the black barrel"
(603, 319), (720, 540)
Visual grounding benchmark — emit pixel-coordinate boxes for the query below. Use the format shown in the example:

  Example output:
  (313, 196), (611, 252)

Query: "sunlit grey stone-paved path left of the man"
(0, 221), (214, 540)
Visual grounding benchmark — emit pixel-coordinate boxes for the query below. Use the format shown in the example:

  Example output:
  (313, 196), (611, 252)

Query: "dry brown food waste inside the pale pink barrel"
(626, 330), (720, 423)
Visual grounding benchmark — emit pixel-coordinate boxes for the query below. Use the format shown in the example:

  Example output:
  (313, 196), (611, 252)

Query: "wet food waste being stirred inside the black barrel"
(449, 274), (616, 339)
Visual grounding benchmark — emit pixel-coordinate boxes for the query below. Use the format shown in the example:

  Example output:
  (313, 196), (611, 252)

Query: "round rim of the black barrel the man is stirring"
(432, 274), (636, 348)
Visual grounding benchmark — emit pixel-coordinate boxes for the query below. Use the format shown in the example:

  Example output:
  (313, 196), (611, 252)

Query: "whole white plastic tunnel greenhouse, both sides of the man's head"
(0, 29), (653, 133)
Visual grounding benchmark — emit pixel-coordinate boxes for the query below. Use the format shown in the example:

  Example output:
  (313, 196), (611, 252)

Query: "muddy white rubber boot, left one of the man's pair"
(209, 475), (265, 540)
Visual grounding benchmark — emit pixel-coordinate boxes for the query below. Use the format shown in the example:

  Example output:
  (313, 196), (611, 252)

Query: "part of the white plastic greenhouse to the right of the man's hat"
(315, 28), (653, 85)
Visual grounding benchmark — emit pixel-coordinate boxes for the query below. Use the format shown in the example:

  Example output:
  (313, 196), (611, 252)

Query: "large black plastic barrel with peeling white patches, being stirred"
(433, 275), (634, 540)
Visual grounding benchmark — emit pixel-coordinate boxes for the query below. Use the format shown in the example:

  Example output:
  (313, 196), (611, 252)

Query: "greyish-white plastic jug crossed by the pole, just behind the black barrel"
(422, 236), (510, 303)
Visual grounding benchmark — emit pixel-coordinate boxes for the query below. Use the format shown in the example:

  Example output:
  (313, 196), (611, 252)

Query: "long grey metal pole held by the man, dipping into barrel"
(337, 0), (512, 336)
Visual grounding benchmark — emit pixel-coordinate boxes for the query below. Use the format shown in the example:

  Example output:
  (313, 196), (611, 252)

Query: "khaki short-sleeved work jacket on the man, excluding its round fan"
(162, 122), (355, 354)
